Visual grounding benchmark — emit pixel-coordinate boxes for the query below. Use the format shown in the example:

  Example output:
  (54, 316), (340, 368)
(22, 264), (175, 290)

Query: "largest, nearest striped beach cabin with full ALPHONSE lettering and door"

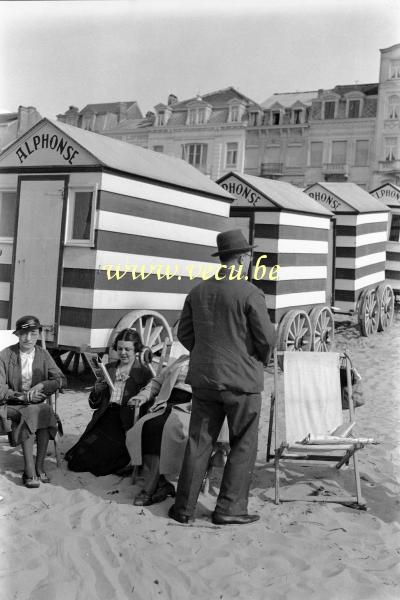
(0, 119), (232, 367)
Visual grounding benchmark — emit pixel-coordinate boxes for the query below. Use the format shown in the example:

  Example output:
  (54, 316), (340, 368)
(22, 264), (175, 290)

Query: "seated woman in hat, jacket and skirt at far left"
(0, 315), (66, 488)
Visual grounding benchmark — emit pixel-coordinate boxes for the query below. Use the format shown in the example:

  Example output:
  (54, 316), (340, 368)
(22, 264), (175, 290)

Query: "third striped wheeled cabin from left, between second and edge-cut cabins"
(305, 182), (394, 336)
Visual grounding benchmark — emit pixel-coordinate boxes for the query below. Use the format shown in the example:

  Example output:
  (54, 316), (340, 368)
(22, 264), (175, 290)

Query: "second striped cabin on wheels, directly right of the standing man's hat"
(218, 172), (334, 350)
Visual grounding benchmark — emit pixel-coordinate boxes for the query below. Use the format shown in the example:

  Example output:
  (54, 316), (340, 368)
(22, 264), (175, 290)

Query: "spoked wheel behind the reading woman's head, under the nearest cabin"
(109, 310), (172, 356)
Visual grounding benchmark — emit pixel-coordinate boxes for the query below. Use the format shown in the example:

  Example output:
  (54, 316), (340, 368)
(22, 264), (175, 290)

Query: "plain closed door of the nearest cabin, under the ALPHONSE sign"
(11, 178), (66, 342)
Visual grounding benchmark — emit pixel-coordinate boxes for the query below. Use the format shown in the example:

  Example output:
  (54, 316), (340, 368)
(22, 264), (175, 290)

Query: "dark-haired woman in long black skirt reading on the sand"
(65, 329), (152, 476)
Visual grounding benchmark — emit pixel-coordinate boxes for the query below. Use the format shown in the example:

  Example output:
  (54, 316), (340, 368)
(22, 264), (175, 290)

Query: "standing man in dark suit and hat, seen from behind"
(168, 229), (275, 525)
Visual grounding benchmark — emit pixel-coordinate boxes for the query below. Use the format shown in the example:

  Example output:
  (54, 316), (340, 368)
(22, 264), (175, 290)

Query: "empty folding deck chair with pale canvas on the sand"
(267, 350), (374, 509)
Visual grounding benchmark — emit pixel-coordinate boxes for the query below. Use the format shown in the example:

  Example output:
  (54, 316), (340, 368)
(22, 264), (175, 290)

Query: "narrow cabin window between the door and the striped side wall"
(67, 188), (95, 246)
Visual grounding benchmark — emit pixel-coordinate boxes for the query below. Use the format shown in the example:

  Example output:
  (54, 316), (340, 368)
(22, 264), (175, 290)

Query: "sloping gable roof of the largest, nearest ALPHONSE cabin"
(0, 118), (232, 201)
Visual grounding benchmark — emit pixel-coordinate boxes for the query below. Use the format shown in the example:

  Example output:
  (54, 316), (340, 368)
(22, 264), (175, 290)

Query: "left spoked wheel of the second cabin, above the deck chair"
(278, 309), (312, 352)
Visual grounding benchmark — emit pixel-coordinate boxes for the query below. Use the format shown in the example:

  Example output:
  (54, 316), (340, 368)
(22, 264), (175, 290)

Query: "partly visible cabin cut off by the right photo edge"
(370, 183), (400, 296)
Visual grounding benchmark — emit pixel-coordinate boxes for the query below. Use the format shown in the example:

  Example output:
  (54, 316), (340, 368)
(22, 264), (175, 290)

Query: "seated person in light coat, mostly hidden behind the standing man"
(126, 355), (192, 506)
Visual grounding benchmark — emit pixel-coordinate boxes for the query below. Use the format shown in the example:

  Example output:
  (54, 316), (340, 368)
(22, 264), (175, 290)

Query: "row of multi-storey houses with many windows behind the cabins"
(58, 44), (400, 190)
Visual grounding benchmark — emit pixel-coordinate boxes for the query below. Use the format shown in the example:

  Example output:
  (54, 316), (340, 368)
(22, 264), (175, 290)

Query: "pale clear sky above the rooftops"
(0, 0), (400, 118)
